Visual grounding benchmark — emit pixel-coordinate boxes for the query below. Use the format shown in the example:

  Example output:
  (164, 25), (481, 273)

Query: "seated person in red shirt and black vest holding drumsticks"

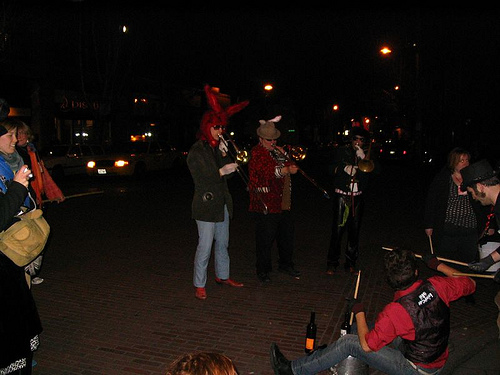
(270, 249), (476, 375)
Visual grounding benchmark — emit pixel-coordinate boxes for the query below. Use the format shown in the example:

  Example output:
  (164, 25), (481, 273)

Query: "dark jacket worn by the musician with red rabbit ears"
(187, 140), (233, 222)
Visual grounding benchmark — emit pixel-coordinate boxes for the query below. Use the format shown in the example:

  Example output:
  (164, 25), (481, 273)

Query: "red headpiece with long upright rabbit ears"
(198, 85), (249, 147)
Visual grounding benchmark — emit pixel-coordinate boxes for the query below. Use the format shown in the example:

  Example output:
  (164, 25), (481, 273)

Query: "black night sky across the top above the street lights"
(3, 0), (500, 131)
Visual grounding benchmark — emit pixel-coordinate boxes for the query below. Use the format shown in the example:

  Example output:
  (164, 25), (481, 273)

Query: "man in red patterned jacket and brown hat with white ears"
(248, 116), (300, 283)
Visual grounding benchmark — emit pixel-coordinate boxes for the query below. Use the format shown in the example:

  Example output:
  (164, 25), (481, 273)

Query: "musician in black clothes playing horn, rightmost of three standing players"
(326, 125), (379, 275)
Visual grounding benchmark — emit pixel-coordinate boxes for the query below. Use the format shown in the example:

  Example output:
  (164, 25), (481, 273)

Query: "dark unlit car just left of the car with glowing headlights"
(41, 143), (105, 181)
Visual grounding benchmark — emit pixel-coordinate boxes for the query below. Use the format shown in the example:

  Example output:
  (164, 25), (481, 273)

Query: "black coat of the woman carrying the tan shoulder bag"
(0, 182), (42, 368)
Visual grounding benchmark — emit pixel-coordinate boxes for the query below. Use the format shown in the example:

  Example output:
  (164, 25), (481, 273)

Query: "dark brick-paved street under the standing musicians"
(29, 163), (498, 375)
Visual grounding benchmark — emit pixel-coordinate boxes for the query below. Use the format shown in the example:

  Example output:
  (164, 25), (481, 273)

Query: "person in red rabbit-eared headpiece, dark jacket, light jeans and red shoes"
(187, 85), (248, 300)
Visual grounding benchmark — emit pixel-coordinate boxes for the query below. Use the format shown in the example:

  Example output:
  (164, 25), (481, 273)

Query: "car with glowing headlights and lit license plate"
(87, 141), (182, 177)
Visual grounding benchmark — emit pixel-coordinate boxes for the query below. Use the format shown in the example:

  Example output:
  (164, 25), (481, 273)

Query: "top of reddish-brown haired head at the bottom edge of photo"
(166, 352), (238, 375)
